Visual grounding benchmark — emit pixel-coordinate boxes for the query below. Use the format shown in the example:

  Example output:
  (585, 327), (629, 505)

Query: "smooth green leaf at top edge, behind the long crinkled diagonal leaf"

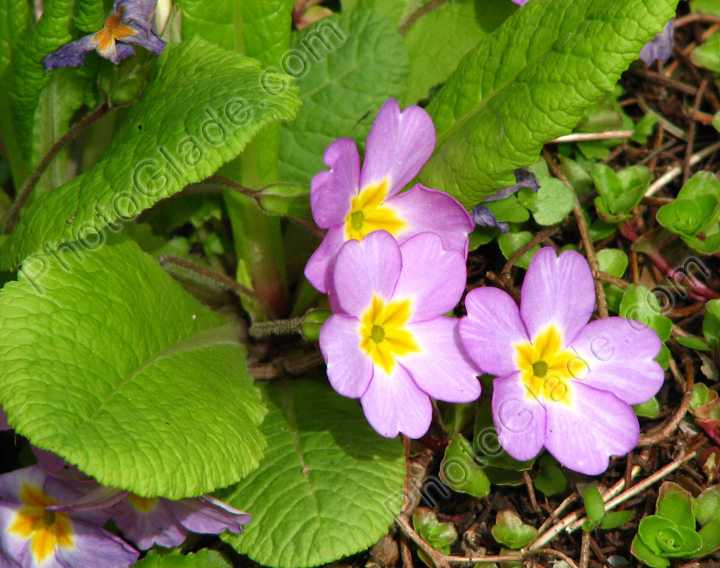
(404, 0), (516, 105)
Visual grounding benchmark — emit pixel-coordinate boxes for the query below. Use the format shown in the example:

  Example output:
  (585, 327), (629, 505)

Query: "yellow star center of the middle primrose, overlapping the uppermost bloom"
(360, 296), (420, 375)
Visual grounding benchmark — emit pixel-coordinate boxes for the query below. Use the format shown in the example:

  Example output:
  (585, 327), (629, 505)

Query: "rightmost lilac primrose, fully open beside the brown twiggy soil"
(460, 247), (665, 475)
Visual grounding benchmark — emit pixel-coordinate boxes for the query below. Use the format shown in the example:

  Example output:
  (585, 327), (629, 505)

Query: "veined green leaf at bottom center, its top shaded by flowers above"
(220, 379), (405, 568)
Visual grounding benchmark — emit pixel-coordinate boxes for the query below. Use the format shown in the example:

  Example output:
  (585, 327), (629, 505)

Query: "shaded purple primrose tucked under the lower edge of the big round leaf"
(51, 486), (251, 550)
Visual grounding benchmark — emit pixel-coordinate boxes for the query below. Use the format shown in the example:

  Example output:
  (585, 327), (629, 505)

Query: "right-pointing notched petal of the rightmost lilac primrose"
(570, 317), (665, 404)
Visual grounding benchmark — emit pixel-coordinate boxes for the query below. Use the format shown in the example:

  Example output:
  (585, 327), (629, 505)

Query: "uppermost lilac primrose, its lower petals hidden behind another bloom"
(305, 99), (473, 301)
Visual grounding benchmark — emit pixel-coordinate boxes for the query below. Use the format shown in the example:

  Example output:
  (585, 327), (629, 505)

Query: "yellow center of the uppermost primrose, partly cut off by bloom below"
(345, 180), (407, 241)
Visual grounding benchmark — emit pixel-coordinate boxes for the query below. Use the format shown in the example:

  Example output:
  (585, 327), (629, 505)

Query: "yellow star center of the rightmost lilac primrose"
(514, 325), (588, 404)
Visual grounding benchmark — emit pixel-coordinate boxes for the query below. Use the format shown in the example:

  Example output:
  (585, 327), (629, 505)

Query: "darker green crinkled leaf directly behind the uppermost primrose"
(280, 10), (408, 184)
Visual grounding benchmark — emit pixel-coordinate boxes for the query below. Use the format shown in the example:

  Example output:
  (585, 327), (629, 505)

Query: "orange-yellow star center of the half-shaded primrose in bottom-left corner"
(8, 483), (75, 564)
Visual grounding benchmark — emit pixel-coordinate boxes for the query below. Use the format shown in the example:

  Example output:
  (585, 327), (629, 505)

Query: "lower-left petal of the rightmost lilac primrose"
(492, 373), (547, 461)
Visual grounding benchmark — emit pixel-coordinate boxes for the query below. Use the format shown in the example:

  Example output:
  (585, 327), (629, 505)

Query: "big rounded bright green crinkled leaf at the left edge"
(0, 235), (265, 499)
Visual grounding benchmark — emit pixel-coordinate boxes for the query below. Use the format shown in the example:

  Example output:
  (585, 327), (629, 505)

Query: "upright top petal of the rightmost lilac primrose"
(520, 247), (595, 346)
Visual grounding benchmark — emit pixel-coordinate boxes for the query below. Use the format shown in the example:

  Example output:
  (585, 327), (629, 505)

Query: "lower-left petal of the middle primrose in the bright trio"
(320, 314), (373, 398)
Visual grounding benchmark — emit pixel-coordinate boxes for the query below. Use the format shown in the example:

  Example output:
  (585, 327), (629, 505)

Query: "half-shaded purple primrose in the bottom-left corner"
(0, 466), (139, 568)
